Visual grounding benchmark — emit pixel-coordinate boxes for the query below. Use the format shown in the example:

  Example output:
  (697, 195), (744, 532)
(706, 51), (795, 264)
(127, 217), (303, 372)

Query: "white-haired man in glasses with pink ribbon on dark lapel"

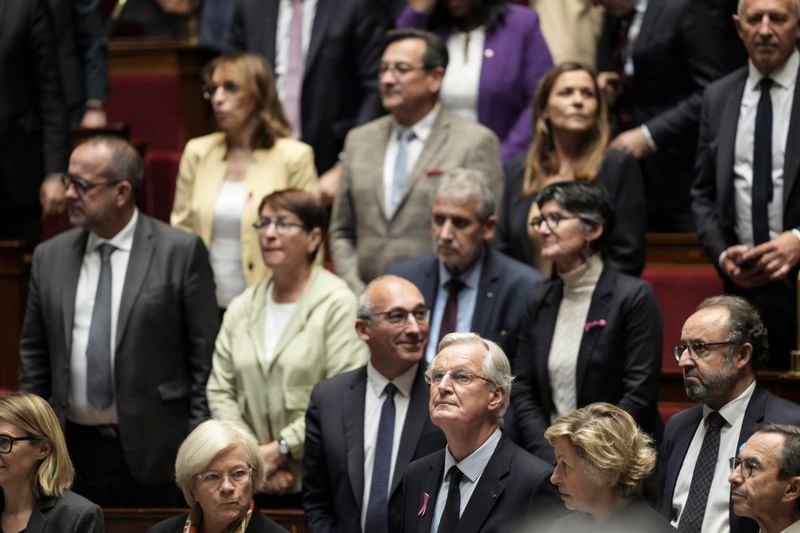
(390, 333), (562, 533)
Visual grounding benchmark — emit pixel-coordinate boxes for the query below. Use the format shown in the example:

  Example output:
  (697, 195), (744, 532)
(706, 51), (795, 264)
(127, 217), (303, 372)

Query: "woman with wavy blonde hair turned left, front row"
(544, 402), (674, 533)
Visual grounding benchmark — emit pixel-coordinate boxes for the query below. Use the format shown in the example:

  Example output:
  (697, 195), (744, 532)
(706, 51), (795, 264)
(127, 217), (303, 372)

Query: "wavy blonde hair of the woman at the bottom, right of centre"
(544, 402), (656, 497)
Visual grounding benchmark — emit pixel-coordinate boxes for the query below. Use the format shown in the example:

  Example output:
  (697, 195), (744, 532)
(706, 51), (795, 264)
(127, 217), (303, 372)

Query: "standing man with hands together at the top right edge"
(692, 0), (800, 368)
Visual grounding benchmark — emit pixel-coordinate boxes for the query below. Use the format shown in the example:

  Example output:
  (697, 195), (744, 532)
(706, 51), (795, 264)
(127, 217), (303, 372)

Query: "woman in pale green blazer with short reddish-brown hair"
(206, 189), (367, 507)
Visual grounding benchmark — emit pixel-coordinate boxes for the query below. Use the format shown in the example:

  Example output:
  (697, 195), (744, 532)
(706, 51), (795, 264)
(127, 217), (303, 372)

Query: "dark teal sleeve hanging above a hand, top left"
(73, 0), (108, 101)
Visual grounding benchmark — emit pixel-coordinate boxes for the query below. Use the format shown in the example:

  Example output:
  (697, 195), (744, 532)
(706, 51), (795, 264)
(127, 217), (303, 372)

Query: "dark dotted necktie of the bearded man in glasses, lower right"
(678, 411), (725, 533)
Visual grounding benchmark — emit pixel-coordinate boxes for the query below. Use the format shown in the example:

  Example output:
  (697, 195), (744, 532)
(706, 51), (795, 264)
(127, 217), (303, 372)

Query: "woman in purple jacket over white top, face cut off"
(397, 0), (553, 162)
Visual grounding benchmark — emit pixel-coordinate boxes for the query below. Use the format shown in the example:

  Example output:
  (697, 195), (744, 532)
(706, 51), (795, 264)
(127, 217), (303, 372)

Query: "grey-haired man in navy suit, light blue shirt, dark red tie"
(388, 168), (544, 368)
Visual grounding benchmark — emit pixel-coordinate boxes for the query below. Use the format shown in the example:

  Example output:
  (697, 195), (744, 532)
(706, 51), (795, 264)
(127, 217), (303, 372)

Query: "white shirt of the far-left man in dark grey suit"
(67, 209), (139, 426)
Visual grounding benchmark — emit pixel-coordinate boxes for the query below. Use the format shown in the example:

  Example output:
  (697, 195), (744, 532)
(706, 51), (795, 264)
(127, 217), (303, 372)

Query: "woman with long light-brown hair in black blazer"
(495, 62), (646, 276)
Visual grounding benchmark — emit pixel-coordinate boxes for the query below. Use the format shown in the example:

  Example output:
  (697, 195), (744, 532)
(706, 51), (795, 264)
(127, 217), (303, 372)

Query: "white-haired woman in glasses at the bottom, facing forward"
(148, 420), (286, 533)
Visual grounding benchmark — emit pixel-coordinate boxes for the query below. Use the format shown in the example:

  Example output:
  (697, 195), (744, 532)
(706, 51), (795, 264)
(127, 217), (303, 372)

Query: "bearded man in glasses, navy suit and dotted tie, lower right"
(659, 296), (800, 533)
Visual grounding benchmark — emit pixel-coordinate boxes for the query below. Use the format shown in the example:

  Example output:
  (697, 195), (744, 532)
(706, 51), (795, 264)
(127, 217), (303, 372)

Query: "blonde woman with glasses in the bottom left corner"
(0, 392), (104, 533)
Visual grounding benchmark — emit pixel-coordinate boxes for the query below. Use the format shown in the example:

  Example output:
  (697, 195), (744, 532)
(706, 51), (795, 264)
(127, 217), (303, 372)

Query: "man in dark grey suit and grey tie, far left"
(20, 137), (219, 507)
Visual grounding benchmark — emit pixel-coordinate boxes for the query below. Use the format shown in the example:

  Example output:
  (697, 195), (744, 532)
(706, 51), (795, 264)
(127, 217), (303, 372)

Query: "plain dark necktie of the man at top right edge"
(751, 78), (772, 245)
